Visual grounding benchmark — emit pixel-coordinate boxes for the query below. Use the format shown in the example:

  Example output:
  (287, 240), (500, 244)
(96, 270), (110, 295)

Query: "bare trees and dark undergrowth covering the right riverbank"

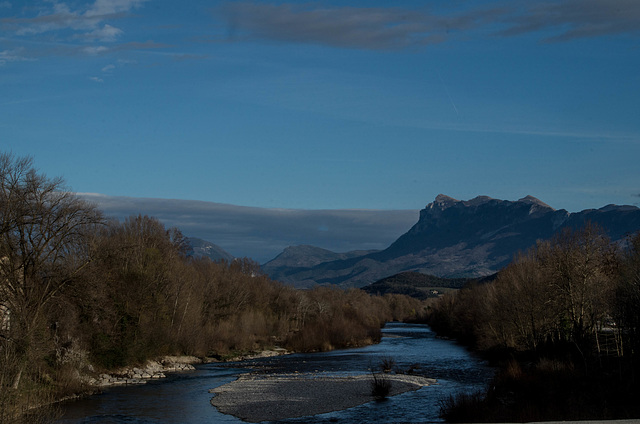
(428, 224), (640, 422)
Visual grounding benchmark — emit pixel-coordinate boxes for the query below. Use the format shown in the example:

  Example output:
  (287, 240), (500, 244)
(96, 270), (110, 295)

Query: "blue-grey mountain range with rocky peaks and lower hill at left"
(263, 194), (640, 287)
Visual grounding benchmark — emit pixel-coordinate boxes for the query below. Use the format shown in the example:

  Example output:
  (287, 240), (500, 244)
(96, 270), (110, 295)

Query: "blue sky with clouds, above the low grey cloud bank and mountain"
(0, 0), (640, 262)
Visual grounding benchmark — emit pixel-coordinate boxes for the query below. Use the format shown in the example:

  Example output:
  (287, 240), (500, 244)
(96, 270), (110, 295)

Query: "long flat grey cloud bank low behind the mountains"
(82, 193), (418, 263)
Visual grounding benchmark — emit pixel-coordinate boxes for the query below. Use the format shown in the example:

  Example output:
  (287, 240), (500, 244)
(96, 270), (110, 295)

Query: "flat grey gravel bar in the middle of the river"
(210, 373), (435, 423)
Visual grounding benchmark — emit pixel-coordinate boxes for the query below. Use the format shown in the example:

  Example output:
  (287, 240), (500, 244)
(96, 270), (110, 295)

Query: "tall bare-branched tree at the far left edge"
(0, 154), (102, 388)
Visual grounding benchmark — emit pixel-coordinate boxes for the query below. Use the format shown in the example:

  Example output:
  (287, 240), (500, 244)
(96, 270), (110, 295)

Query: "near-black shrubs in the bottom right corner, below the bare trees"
(441, 359), (640, 422)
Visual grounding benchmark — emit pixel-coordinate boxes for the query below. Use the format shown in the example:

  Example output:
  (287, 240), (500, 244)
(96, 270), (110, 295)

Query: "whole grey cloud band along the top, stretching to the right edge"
(219, 0), (640, 50)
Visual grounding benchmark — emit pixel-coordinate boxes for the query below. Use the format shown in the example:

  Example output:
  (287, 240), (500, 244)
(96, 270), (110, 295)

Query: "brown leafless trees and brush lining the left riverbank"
(0, 154), (424, 423)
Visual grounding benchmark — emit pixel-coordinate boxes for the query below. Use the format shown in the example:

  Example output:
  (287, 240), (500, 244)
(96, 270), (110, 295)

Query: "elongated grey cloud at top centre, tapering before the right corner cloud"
(220, 2), (496, 50)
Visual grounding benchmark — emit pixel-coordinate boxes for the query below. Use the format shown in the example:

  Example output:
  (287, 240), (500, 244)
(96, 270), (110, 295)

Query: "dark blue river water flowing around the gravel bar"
(59, 323), (493, 424)
